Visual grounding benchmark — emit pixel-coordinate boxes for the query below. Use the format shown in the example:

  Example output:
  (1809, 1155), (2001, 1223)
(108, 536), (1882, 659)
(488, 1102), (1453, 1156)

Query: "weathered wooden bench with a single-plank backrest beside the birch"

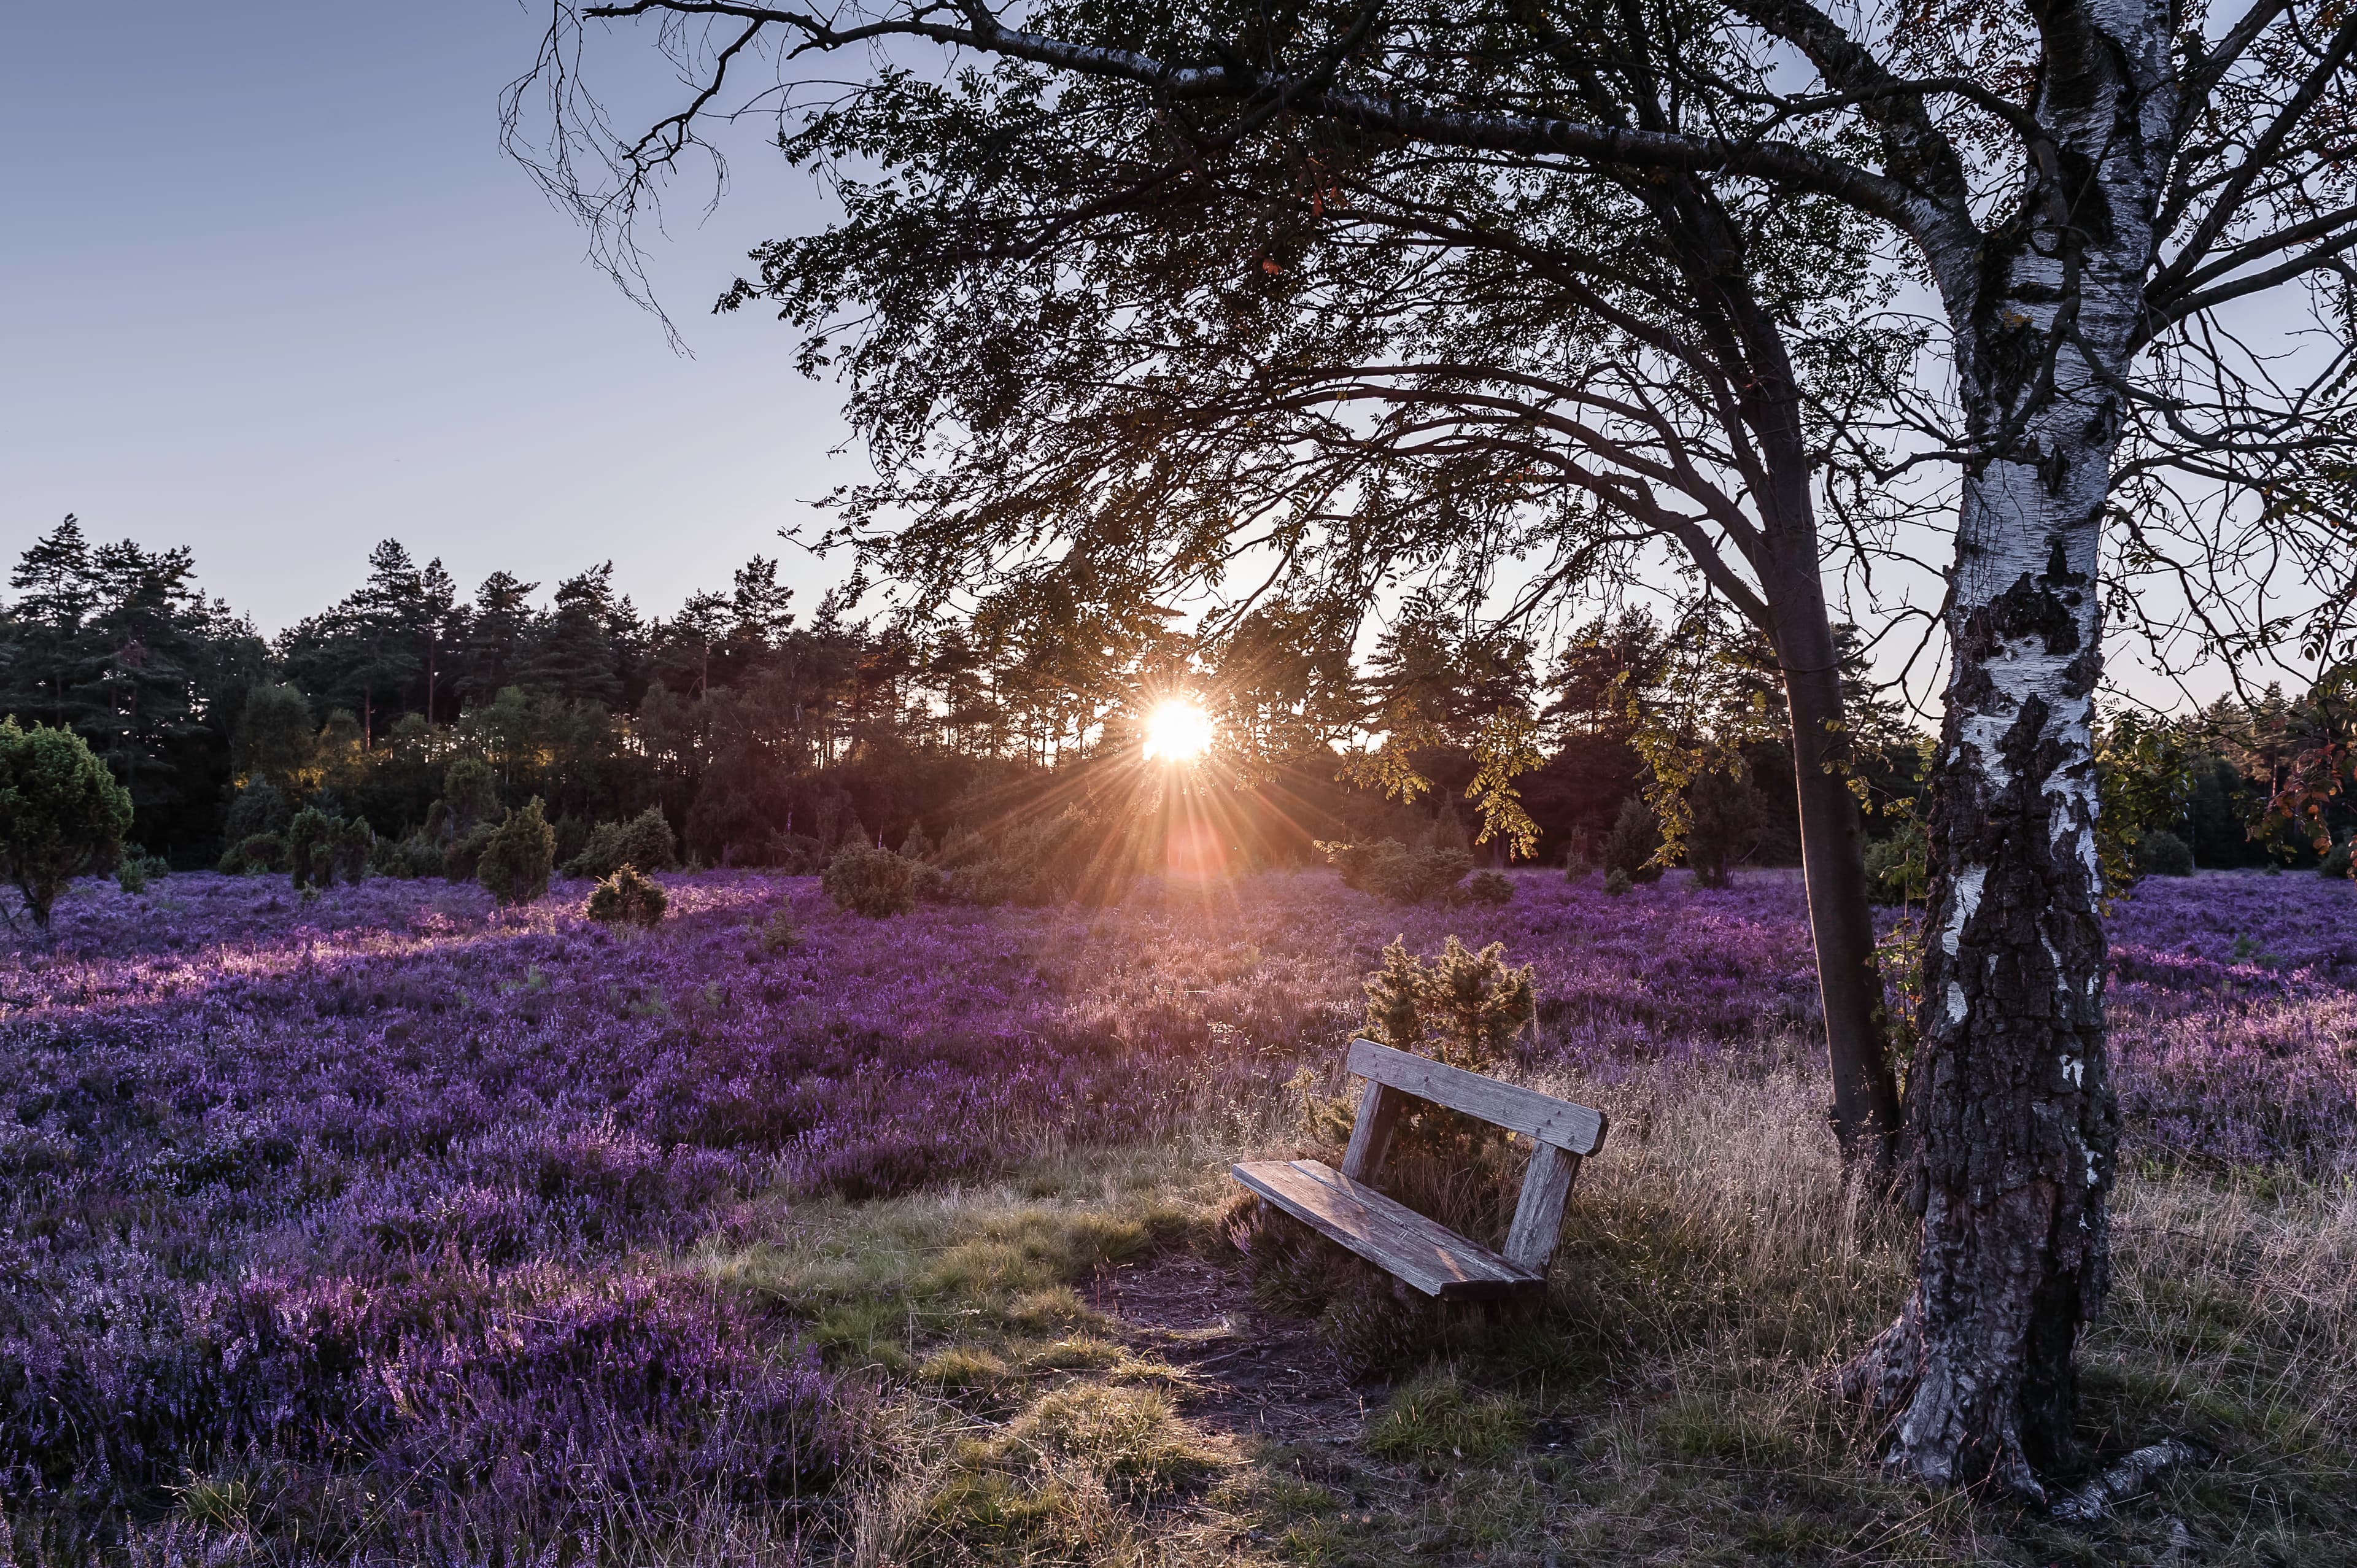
(1230, 1040), (1605, 1302)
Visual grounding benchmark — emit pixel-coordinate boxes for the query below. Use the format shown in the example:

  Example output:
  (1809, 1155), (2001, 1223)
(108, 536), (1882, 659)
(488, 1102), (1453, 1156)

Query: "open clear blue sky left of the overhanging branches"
(0, 0), (862, 632)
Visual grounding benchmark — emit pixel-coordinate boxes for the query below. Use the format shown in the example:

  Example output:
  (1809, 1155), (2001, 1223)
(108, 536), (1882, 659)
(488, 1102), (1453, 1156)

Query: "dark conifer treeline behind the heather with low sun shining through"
(0, 516), (2338, 865)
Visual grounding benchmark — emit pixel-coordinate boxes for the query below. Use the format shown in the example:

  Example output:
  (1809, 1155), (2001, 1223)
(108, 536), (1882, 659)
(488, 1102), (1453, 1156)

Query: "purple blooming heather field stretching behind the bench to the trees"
(0, 873), (2357, 1500)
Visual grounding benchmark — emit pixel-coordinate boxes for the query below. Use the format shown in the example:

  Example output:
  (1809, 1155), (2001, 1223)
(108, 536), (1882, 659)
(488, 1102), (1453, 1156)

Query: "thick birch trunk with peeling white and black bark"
(1848, 5), (2169, 1497)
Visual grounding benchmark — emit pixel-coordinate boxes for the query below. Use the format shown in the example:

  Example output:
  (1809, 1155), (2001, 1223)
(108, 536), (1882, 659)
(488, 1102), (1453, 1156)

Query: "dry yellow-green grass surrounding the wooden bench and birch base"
(655, 1070), (2357, 1568)
